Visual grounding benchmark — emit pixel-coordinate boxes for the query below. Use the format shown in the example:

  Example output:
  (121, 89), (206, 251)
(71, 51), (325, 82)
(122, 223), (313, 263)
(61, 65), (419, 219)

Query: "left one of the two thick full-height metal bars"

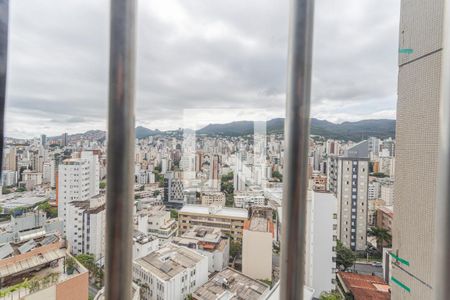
(105, 0), (136, 300)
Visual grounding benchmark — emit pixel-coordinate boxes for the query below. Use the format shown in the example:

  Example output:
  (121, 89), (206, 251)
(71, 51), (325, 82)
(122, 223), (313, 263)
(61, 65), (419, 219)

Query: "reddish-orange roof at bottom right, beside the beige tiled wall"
(337, 272), (391, 300)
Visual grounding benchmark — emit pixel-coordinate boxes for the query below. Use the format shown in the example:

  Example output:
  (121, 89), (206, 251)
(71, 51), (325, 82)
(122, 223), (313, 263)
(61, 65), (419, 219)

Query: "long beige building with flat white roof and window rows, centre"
(178, 205), (248, 241)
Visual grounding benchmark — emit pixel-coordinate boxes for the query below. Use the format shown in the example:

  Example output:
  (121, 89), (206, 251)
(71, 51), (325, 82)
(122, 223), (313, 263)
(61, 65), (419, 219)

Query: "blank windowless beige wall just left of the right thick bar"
(242, 229), (273, 280)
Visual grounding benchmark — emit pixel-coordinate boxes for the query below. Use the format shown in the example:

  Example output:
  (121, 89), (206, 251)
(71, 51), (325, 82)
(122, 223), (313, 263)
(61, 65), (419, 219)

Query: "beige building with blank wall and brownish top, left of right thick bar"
(242, 209), (274, 280)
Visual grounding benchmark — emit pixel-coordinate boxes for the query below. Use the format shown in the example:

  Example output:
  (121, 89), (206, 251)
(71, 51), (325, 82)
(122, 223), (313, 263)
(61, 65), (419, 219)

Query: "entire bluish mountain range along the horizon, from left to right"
(49, 118), (395, 141)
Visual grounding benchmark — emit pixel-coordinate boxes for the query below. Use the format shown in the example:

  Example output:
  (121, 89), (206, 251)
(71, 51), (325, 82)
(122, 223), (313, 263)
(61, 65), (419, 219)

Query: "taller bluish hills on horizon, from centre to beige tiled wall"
(197, 118), (395, 141)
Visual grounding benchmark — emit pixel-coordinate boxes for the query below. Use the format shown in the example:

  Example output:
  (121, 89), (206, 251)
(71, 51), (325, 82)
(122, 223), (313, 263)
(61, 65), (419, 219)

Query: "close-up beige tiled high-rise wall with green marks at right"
(390, 0), (446, 300)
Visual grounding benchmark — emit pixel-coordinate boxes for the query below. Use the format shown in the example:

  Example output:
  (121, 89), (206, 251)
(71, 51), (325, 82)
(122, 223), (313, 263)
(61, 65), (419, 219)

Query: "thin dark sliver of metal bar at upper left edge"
(0, 0), (9, 174)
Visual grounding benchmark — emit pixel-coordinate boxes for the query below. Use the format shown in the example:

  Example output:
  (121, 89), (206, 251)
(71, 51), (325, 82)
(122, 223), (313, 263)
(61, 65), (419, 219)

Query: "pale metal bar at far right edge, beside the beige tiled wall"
(433, 1), (450, 299)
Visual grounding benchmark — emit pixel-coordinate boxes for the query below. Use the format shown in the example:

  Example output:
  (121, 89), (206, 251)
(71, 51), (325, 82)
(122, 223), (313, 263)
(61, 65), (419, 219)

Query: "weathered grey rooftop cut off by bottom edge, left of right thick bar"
(192, 268), (269, 300)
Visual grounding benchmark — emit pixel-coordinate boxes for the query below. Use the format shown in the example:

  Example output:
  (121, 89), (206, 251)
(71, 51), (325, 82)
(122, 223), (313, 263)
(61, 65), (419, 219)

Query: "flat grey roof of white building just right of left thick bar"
(134, 244), (206, 280)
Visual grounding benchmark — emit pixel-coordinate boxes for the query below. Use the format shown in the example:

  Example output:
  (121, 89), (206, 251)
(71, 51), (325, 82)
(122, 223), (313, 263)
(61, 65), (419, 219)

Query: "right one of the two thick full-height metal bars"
(280, 0), (314, 300)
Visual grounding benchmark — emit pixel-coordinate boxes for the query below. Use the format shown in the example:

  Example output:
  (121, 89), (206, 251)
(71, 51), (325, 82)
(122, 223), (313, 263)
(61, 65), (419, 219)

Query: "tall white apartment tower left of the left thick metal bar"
(56, 152), (99, 233)
